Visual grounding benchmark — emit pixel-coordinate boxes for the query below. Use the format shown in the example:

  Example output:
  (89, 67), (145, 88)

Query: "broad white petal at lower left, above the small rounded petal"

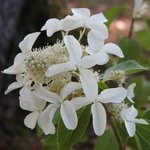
(19, 87), (46, 111)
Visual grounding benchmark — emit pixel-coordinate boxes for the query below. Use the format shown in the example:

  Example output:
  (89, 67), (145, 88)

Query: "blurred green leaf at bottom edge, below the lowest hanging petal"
(94, 129), (119, 150)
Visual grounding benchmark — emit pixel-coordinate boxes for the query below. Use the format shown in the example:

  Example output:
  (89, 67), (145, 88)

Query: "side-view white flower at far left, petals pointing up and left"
(2, 32), (40, 74)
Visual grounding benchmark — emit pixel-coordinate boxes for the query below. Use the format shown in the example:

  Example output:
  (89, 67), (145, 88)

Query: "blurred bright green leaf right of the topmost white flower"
(104, 5), (125, 26)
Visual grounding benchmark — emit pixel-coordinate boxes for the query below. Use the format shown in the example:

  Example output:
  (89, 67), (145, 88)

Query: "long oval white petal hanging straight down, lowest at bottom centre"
(91, 102), (106, 136)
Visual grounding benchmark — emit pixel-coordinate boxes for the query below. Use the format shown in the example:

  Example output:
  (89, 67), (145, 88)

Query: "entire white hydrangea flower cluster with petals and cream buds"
(3, 8), (147, 136)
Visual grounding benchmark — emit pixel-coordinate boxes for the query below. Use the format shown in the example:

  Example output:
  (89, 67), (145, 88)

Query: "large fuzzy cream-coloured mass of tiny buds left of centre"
(25, 43), (72, 93)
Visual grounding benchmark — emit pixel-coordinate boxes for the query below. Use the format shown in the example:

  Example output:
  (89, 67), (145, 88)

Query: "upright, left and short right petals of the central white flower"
(46, 35), (95, 77)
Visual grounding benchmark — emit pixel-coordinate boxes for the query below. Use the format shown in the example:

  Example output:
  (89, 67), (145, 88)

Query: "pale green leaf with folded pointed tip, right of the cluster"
(103, 60), (148, 80)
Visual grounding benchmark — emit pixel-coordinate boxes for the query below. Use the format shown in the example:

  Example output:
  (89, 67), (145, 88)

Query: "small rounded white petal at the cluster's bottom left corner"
(24, 112), (39, 129)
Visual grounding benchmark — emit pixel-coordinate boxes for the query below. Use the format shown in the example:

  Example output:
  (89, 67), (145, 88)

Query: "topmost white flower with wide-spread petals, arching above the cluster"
(41, 8), (108, 39)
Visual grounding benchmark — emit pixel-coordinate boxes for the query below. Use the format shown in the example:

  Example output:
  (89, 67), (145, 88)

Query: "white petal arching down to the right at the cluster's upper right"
(101, 43), (124, 58)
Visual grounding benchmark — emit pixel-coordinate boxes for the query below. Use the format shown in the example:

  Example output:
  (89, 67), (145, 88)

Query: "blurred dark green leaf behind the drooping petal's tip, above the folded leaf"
(119, 37), (141, 62)
